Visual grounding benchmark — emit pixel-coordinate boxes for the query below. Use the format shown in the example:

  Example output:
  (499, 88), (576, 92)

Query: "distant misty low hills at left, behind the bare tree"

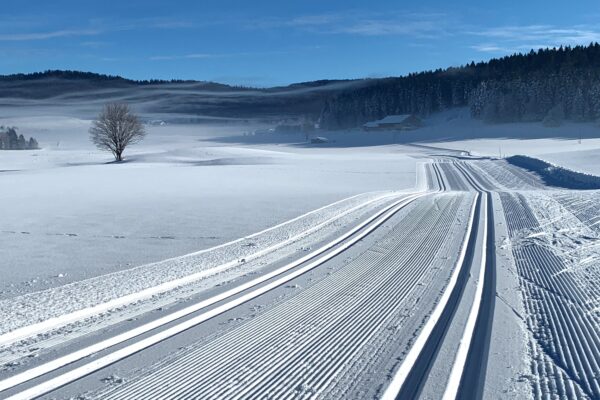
(0, 70), (365, 121)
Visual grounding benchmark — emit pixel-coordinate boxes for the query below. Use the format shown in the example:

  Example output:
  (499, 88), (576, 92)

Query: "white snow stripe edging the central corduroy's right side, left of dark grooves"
(381, 194), (480, 400)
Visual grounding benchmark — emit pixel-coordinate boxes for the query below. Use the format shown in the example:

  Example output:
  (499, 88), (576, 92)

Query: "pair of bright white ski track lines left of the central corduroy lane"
(0, 194), (425, 399)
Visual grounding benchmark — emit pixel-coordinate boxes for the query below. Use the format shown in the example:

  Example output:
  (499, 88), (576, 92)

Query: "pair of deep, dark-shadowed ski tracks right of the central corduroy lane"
(383, 162), (495, 400)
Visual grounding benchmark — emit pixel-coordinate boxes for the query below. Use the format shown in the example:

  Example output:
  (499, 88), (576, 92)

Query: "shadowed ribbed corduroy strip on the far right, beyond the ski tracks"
(501, 193), (600, 399)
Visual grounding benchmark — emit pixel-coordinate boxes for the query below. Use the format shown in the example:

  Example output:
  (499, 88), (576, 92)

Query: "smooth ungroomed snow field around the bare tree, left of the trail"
(0, 117), (418, 297)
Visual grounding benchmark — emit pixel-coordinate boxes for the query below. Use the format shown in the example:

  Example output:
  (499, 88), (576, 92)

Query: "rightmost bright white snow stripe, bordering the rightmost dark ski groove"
(442, 196), (488, 400)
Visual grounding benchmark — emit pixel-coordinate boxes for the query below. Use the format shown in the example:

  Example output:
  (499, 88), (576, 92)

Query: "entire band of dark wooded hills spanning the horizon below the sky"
(7, 43), (600, 129)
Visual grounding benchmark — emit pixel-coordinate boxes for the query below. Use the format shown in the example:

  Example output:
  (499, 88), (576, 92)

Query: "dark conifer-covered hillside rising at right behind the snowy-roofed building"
(320, 43), (600, 129)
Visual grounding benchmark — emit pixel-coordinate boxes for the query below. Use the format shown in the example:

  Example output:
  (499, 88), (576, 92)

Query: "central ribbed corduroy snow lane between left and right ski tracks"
(103, 195), (466, 399)
